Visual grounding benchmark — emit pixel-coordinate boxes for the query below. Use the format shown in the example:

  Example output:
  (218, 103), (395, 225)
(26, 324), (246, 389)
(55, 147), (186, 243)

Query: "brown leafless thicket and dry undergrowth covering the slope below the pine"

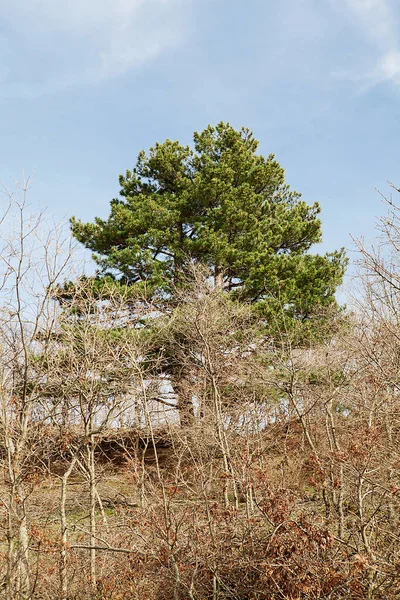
(0, 185), (400, 600)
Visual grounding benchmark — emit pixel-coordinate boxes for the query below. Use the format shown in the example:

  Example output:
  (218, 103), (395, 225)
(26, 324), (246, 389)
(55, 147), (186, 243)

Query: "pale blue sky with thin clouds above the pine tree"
(0, 0), (400, 288)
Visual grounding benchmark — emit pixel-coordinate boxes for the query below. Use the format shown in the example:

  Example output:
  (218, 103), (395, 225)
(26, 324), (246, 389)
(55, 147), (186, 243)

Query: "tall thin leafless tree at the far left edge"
(0, 180), (72, 600)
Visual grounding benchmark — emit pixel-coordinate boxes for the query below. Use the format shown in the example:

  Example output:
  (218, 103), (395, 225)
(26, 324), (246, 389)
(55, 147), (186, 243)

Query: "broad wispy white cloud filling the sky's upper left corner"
(0, 0), (190, 97)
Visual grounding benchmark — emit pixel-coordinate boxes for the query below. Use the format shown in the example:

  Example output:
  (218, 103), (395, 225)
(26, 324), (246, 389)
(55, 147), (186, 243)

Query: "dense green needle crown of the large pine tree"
(71, 123), (346, 318)
